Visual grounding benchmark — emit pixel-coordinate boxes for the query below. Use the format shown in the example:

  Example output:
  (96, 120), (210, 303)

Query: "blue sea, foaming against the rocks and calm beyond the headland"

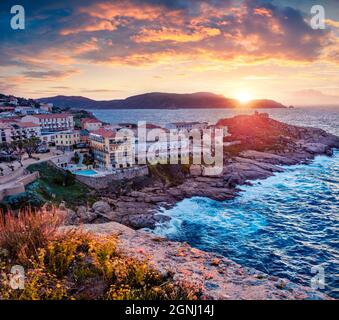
(91, 107), (339, 299)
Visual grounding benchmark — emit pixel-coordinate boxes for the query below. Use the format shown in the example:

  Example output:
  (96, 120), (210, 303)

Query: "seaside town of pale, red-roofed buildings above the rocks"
(0, 95), (228, 200)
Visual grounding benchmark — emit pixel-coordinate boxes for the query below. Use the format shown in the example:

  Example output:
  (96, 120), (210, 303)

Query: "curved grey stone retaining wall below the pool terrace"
(76, 166), (149, 190)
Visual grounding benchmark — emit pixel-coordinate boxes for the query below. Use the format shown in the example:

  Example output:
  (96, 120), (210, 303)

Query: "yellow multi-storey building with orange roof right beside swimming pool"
(89, 128), (134, 170)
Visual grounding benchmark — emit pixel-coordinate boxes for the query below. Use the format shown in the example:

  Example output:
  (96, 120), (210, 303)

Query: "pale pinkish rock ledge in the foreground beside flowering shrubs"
(63, 222), (329, 300)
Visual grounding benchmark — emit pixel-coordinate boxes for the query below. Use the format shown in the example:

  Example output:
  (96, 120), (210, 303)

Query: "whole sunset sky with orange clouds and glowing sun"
(0, 0), (339, 105)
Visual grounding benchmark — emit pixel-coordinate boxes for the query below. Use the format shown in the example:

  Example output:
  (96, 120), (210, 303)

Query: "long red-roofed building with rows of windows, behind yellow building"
(21, 113), (74, 132)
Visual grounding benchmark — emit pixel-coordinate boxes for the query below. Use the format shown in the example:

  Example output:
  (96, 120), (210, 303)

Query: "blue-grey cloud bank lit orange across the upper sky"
(0, 0), (333, 74)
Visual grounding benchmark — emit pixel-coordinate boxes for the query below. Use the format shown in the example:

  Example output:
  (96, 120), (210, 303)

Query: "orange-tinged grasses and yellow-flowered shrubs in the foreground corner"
(0, 211), (201, 300)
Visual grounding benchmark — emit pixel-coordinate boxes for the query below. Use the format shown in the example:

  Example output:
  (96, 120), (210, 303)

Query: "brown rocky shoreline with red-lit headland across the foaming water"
(64, 116), (339, 229)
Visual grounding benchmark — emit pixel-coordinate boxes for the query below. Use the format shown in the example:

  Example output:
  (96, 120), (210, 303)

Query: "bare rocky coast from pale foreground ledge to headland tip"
(56, 115), (339, 299)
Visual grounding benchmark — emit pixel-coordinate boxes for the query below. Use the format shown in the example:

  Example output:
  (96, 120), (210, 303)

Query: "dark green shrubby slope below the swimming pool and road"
(27, 162), (95, 207)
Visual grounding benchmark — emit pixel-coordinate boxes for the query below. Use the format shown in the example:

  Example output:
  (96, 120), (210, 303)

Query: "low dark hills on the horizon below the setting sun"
(37, 92), (286, 109)
